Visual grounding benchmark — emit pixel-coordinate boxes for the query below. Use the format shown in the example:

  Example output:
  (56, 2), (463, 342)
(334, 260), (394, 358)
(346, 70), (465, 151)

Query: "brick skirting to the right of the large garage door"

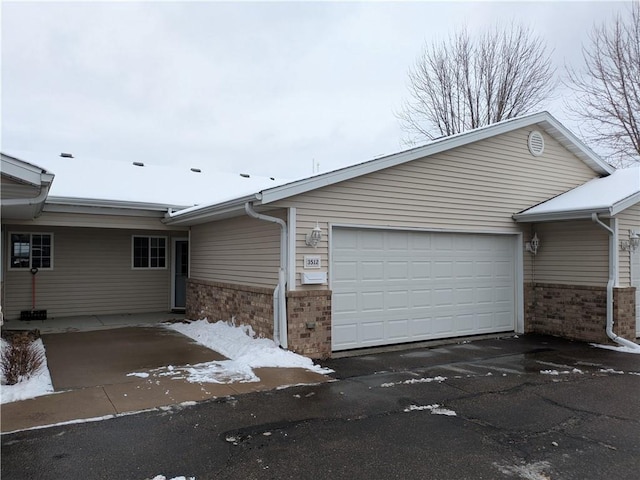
(524, 283), (636, 343)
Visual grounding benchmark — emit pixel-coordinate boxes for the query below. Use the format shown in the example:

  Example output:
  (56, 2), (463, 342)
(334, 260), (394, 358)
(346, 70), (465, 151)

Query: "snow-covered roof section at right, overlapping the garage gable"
(513, 167), (640, 222)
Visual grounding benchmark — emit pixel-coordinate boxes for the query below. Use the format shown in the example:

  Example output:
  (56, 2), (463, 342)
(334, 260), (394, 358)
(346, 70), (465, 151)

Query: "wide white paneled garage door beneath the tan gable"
(331, 228), (516, 351)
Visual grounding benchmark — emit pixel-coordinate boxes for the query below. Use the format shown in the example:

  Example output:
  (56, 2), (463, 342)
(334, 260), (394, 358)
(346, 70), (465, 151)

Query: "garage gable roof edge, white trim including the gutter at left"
(165, 112), (615, 224)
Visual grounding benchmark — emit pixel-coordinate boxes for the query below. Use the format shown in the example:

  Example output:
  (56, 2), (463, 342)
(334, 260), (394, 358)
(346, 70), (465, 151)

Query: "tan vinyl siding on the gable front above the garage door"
(276, 128), (597, 283)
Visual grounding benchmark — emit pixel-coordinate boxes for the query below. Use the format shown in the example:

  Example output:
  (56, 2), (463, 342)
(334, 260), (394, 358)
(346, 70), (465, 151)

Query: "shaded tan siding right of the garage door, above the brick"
(525, 220), (609, 286)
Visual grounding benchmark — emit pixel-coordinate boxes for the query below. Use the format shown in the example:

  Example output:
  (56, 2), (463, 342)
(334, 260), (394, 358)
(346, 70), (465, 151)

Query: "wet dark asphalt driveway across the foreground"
(1, 336), (640, 480)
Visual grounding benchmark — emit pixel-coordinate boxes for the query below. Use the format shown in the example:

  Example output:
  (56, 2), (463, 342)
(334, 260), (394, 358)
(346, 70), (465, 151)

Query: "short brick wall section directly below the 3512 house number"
(287, 290), (331, 358)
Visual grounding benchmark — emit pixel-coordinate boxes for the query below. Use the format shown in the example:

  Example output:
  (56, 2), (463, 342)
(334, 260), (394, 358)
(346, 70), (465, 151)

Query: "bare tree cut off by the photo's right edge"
(565, 1), (640, 166)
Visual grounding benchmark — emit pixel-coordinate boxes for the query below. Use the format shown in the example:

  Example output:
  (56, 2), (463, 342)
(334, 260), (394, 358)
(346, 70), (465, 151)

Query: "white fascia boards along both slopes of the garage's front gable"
(259, 112), (615, 204)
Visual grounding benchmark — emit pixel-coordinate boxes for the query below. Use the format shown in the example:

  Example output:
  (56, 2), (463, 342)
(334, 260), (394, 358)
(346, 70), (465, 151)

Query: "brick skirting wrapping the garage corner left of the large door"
(186, 279), (331, 358)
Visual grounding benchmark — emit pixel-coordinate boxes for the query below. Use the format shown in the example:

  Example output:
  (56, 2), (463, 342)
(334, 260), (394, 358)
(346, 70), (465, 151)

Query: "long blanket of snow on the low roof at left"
(3, 152), (286, 207)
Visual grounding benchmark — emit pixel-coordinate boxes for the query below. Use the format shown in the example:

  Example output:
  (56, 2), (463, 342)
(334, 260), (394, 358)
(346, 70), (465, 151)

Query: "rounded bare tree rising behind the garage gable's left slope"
(397, 24), (555, 143)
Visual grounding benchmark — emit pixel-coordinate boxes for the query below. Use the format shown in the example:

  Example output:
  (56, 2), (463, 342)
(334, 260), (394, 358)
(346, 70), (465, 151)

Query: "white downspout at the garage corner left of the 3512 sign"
(244, 202), (288, 348)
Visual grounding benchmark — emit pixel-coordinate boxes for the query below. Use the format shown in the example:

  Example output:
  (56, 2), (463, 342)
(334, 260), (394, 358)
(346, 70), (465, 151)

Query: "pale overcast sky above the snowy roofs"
(1, 1), (628, 178)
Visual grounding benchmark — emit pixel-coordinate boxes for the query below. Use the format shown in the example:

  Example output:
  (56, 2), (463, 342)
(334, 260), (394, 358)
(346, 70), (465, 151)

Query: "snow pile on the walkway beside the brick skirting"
(166, 320), (333, 383)
